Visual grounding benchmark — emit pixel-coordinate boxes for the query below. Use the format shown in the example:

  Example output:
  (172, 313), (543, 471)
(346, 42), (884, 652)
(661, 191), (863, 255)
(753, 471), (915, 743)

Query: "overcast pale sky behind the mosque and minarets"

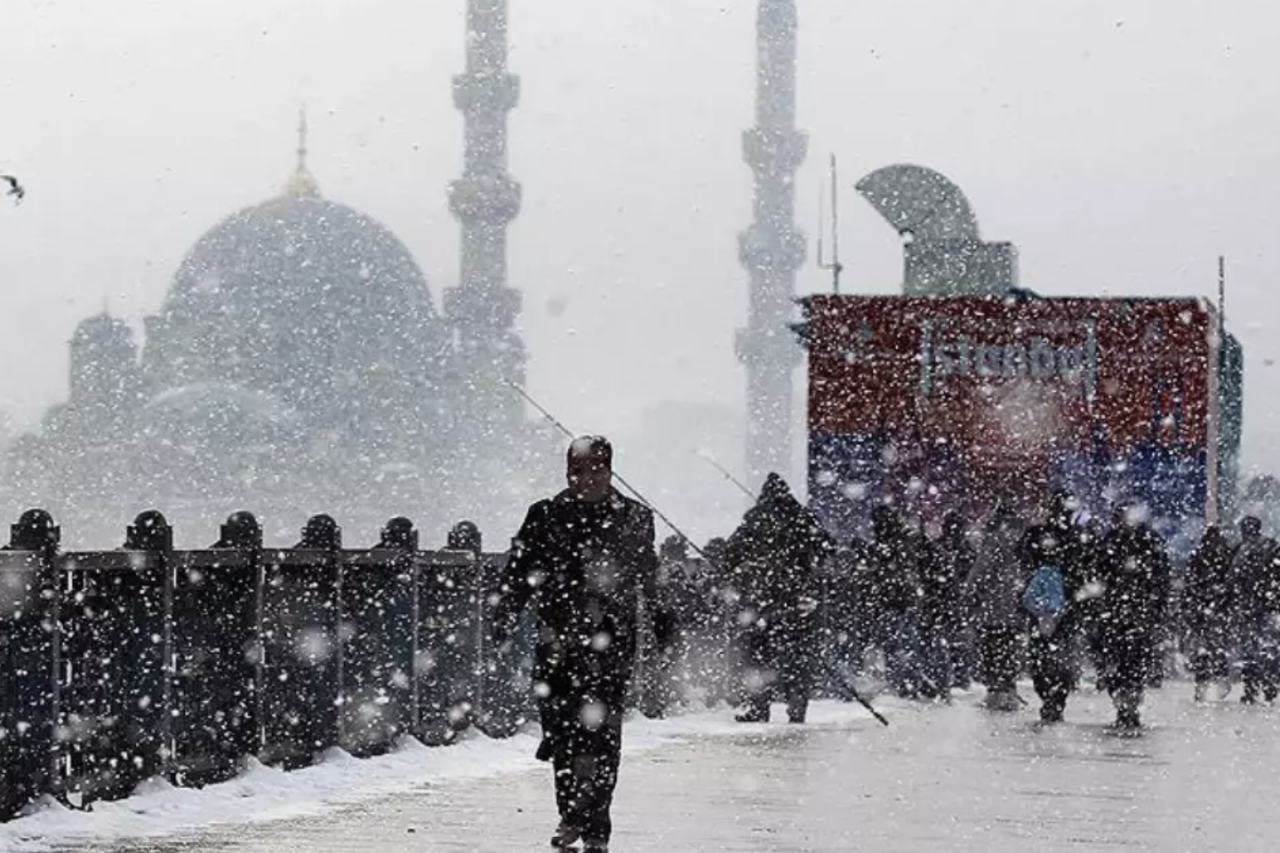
(0, 0), (1280, 479)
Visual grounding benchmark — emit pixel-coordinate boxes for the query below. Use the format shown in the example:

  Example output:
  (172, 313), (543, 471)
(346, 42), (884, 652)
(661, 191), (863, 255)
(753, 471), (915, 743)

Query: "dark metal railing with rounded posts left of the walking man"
(0, 507), (545, 820)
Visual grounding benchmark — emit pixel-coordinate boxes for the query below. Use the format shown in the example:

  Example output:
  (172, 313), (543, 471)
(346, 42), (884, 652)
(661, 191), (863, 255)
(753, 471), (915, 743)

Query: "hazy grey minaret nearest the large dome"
(444, 0), (526, 427)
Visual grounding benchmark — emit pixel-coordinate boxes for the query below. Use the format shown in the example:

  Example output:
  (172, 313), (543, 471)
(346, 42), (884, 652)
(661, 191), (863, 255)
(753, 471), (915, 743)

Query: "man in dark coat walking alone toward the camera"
(493, 435), (673, 853)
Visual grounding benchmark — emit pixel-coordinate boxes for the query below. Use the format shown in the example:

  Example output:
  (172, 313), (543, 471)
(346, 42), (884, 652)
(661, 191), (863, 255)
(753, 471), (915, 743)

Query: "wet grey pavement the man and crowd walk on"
(45, 685), (1280, 853)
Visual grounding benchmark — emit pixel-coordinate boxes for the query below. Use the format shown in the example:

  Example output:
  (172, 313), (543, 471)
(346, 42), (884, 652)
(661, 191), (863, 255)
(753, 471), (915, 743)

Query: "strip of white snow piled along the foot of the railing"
(0, 702), (885, 853)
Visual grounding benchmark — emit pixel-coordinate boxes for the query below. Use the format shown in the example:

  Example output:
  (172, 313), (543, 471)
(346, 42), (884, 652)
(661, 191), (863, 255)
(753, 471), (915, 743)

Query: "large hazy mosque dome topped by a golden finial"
(143, 133), (444, 410)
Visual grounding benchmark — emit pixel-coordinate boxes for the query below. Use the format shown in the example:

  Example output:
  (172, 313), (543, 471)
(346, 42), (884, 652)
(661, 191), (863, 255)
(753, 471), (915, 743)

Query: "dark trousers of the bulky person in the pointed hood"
(744, 616), (818, 720)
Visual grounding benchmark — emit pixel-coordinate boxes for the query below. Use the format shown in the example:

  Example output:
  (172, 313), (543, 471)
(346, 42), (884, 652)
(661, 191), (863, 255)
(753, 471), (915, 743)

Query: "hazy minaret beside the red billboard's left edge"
(737, 0), (808, 483)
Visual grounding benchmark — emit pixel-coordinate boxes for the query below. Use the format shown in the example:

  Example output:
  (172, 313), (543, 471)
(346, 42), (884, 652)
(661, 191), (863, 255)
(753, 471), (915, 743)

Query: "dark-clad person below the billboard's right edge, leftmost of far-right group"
(1181, 524), (1234, 702)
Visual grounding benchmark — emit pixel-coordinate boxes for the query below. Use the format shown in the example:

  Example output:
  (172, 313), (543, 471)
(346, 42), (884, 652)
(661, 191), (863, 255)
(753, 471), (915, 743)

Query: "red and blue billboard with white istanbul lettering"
(808, 296), (1217, 532)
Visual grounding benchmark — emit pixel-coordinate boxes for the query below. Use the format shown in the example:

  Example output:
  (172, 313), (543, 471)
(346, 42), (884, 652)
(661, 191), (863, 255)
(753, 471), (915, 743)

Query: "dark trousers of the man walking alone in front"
(535, 637), (632, 843)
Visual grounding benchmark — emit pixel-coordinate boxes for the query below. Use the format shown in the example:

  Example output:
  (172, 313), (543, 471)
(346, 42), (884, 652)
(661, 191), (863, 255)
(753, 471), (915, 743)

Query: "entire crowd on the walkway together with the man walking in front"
(483, 437), (1280, 853)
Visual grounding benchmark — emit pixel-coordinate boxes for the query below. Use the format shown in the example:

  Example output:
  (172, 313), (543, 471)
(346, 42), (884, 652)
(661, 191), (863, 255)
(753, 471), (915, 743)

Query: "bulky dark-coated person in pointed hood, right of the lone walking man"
(724, 474), (832, 722)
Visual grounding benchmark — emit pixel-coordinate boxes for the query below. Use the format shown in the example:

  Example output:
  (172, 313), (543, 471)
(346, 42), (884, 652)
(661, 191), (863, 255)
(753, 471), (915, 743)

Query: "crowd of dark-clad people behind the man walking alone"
(650, 475), (1280, 729)
